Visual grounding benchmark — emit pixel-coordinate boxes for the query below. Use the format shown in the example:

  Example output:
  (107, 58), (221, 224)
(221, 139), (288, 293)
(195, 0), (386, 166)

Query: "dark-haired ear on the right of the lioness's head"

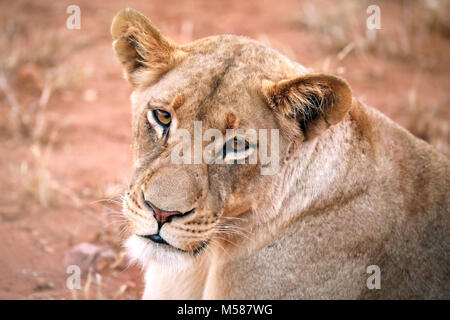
(262, 73), (352, 140)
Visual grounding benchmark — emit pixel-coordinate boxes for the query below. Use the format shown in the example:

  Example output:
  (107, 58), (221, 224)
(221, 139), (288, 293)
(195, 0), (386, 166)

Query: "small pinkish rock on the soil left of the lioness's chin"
(64, 242), (117, 273)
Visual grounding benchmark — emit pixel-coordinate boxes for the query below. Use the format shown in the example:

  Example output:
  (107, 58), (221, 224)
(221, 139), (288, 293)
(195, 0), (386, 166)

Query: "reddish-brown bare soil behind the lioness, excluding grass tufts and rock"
(0, 0), (450, 299)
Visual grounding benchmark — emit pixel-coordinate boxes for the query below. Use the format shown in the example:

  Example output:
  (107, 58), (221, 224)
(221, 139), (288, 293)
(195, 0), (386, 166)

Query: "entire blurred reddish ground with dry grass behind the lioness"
(0, 0), (450, 299)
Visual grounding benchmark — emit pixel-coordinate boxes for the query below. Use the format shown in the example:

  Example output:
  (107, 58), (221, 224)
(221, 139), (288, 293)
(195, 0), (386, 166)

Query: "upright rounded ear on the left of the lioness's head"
(111, 8), (181, 86)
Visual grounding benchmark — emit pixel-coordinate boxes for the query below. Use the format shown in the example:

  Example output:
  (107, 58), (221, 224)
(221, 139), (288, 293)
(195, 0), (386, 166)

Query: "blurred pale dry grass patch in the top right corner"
(293, 0), (450, 58)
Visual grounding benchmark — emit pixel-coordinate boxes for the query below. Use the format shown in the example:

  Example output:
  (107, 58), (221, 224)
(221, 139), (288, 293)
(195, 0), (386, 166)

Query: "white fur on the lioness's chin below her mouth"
(125, 235), (193, 269)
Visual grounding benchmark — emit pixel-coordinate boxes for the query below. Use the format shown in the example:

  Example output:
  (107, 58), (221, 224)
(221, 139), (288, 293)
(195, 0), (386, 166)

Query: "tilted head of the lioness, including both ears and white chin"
(111, 9), (352, 263)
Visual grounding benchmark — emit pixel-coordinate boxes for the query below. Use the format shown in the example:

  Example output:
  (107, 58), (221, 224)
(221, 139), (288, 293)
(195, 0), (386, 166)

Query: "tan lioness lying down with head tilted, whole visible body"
(111, 9), (450, 299)
